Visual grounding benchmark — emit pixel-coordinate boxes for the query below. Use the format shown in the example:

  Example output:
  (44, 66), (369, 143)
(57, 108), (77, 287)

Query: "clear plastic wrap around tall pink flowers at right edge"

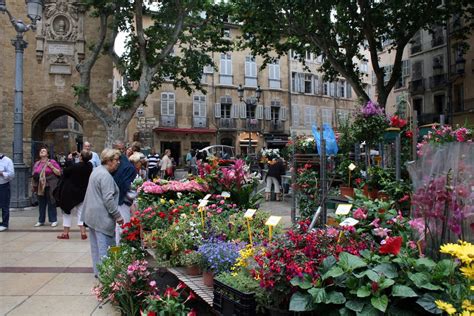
(408, 140), (474, 254)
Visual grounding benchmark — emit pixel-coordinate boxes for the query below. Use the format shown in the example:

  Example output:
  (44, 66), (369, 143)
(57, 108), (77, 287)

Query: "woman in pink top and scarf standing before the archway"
(32, 147), (61, 227)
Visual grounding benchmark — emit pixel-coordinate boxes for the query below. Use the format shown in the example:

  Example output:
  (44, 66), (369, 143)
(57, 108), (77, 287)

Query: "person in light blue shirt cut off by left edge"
(0, 153), (15, 232)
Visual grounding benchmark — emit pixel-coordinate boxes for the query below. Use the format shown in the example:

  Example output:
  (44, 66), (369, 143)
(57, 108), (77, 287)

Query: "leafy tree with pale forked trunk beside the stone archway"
(74, 0), (230, 146)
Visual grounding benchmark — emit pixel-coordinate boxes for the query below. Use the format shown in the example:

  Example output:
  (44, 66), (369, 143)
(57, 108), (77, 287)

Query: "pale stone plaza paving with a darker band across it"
(0, 198), (290, 316)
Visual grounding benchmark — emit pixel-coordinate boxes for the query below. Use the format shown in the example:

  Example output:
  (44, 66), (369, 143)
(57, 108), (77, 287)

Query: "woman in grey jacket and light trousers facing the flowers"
(81, 148), (123, 277)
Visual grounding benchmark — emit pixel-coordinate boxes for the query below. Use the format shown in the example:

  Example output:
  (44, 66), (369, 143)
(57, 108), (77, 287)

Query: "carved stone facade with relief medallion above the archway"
(0, 0), (113, 165)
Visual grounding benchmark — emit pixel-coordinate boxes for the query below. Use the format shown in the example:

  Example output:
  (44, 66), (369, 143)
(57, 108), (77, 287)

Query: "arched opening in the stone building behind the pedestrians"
(31, 104), (83, 161)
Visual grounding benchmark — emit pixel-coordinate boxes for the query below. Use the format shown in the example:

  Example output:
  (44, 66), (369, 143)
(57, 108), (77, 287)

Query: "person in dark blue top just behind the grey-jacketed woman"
(113, 140), (137, 244)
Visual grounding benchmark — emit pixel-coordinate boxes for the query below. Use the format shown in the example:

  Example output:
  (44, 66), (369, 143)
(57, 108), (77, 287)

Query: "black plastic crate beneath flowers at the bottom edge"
(213, 279), (257, 316)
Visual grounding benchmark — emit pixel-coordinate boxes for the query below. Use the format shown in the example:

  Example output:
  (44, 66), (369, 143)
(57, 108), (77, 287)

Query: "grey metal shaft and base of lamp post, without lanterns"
(10, 30), (30, 208)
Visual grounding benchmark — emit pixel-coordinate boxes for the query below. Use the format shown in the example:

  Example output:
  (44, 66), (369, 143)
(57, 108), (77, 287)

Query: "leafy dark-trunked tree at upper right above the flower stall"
(232, 0), (473, 108)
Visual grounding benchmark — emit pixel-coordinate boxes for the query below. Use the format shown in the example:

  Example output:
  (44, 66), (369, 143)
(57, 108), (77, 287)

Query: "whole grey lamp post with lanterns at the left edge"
(0, 0), (43, 208)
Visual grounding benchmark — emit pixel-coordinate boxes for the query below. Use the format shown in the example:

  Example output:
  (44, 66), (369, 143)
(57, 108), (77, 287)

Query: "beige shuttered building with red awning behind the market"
(127, 25), (366, 162)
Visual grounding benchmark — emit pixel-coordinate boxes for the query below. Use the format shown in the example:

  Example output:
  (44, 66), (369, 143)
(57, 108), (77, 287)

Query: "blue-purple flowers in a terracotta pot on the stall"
(198, 240), (244, 287)
